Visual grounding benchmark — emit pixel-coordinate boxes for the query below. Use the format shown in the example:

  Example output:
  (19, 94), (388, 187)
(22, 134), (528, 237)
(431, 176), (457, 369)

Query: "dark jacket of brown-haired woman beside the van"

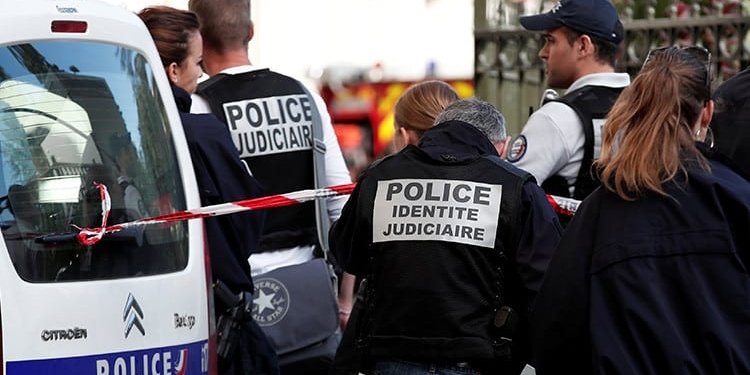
(172, 85), (265, 292)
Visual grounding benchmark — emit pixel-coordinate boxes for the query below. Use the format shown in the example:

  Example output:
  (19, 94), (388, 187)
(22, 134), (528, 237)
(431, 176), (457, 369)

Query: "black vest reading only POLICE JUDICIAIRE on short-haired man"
(197, 69), (317, 252)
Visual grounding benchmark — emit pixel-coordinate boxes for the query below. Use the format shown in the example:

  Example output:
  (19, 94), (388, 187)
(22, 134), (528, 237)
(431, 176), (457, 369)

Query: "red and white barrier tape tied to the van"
(77, 183), (581, 245)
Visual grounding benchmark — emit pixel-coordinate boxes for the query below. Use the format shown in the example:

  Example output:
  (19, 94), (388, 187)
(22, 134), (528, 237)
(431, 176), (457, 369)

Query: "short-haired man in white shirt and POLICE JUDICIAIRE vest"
(188, 0), (354, 375)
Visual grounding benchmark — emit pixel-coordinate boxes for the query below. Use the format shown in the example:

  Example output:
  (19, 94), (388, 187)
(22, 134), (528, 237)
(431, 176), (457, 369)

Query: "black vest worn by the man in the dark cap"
(541, 86), (623, 200)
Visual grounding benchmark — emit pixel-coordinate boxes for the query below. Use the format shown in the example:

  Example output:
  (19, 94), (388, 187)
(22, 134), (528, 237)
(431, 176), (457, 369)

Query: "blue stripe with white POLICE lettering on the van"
(6, 340), (208, 375)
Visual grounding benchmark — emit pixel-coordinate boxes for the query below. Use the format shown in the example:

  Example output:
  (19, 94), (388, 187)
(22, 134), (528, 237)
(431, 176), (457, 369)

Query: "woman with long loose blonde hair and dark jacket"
(531, 47), (750, 375)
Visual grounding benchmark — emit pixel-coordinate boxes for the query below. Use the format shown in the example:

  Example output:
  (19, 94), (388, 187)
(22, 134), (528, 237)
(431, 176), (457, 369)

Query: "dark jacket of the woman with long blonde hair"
(531, 143), (750, 375)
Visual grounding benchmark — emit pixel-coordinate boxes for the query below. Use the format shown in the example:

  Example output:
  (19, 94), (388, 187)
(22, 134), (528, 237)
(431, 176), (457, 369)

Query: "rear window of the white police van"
(0, 41), (188, 282)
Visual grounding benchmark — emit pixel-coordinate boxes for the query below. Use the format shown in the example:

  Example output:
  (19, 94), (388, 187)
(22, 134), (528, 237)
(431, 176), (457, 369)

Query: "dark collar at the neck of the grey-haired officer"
(417, 120), (497, 163)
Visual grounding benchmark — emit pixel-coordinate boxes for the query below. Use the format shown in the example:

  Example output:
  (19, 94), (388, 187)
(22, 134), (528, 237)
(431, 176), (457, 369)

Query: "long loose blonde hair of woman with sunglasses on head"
(595, 47), (710, 201)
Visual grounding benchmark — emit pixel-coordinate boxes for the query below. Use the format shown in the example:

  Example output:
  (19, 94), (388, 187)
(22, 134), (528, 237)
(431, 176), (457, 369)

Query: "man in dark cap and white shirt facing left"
(508, 0), (630, 220)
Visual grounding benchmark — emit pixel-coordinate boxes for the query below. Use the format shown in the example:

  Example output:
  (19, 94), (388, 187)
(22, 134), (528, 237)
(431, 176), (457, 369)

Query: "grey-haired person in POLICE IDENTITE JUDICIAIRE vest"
(331, 99), (561, 374)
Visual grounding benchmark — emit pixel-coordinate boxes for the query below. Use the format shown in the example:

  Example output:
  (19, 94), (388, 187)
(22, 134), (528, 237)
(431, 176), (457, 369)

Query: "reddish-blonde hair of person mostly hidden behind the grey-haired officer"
(393, 80), (460, 137)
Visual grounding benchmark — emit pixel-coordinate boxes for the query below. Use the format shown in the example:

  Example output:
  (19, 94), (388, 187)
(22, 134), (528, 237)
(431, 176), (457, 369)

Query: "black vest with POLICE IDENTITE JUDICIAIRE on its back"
(357, 146), (532, 363)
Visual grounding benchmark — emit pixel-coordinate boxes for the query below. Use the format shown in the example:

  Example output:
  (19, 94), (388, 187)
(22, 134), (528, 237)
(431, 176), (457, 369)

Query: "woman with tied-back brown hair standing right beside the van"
(138, 6), (279, 375)
